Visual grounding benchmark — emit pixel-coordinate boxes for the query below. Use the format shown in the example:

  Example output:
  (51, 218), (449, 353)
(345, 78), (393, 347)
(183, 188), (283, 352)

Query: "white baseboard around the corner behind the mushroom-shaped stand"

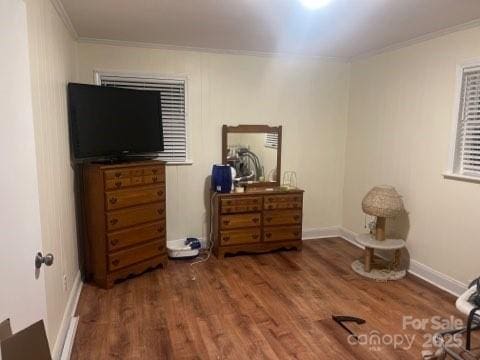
(302, 226), (468, 296)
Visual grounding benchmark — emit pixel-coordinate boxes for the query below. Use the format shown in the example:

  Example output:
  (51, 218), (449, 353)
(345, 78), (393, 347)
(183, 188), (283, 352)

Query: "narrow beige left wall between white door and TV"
(26, 0), (78, 350)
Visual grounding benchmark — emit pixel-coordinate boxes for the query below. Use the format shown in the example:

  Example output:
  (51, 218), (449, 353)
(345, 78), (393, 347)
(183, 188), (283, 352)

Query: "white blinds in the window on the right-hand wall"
(453, 66), (480, 177)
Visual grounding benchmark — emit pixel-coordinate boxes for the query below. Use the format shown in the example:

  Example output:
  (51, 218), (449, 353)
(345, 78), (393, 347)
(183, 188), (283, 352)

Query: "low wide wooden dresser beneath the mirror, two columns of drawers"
(213, 190), (303, 258)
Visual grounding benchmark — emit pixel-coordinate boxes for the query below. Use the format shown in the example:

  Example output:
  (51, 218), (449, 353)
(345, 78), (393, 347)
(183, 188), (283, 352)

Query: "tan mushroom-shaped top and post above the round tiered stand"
(362, 185), (404, 240)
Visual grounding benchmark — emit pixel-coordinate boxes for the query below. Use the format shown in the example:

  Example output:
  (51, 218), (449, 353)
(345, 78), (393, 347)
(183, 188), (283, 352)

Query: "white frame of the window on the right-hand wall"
(443, 59), (480, 183)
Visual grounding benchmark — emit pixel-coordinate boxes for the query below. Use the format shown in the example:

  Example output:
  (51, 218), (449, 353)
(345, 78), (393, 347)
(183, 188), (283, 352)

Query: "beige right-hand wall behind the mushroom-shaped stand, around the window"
(343, 28), (480, 282)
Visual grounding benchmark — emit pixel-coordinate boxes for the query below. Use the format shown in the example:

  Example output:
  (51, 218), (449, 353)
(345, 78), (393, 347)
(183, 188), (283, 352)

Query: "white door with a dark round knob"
(0, 0), (46, 338)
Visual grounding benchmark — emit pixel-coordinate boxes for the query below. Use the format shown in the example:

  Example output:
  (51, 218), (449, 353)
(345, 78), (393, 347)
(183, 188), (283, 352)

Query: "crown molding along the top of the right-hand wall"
(349, 19), (480, 62)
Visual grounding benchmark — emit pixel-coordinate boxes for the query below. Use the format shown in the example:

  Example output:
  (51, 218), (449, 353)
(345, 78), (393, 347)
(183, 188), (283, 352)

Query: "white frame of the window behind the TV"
(93, 70), (193, 165)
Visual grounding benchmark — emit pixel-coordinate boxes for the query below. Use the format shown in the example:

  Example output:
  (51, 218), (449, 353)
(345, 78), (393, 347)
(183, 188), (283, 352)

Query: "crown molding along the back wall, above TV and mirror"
(77, 37), (349, 63)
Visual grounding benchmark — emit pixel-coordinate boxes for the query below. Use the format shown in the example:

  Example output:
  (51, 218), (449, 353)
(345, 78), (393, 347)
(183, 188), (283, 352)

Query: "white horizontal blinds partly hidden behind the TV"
(96, 73), (187, 163)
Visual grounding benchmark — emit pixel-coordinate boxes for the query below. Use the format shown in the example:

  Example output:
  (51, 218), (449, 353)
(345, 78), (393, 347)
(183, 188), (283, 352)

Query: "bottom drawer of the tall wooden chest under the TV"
(108, 241), (165, 271)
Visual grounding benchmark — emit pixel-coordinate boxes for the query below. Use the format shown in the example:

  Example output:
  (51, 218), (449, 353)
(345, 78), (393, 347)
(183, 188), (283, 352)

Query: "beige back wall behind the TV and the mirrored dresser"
(78, 43), (349, 239)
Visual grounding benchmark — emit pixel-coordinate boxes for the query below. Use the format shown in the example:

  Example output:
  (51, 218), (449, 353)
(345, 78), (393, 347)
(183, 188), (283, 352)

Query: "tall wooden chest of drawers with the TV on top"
(83, 161), (167, 288)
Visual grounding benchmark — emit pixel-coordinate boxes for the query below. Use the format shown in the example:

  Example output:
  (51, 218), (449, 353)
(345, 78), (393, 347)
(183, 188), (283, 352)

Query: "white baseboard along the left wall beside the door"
(52, 271), (83, 360)
